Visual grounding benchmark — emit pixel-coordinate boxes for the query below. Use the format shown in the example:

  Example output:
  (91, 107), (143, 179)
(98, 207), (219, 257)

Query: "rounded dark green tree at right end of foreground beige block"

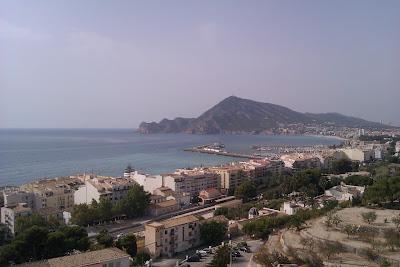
(200, 221), (228, 245)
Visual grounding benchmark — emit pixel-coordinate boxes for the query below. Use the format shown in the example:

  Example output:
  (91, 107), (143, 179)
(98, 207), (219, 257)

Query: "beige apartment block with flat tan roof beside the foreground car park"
(145, 215), (201, 257)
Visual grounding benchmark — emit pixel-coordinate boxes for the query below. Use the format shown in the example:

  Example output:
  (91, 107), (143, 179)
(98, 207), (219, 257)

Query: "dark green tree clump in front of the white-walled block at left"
(71, 184), (150, 226)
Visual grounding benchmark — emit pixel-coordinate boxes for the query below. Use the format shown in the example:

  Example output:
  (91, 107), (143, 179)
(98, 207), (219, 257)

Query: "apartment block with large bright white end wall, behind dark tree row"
(74, 176), (135, 204)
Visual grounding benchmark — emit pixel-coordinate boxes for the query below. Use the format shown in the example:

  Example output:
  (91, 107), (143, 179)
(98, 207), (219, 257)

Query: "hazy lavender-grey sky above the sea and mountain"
(0, 0), (400, 128)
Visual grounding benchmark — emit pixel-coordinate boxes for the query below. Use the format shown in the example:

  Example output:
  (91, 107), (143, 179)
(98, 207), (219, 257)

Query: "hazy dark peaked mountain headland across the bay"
(139, 96), (389, 134)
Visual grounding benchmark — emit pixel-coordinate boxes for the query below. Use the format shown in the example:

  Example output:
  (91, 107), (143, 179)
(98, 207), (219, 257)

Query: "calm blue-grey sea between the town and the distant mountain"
(0, 129), (339, 186)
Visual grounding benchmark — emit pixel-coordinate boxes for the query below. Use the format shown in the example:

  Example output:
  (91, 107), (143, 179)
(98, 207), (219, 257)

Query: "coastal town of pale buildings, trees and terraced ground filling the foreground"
(0, 130), (400, 267)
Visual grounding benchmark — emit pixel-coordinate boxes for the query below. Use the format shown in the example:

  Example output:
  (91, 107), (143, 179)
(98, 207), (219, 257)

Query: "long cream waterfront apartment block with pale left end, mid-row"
(163, 169), (219, 197)
